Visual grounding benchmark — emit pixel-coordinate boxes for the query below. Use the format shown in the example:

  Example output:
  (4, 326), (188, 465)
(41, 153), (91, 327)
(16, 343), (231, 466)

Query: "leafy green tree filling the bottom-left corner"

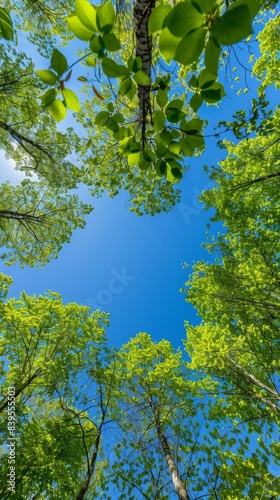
(0, 276), (108, 500)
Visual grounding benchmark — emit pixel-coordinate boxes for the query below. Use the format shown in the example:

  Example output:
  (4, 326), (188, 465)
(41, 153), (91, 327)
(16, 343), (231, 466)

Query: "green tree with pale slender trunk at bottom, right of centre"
(100, 333), (277, 500)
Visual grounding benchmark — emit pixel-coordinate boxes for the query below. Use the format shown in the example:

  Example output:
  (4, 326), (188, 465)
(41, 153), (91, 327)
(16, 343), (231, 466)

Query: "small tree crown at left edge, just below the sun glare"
(0, 179), (92, 267)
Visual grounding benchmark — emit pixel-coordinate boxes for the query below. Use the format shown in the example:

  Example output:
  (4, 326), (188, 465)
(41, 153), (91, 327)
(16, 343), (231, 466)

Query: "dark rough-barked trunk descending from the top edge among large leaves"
(133, 0), (155, 147)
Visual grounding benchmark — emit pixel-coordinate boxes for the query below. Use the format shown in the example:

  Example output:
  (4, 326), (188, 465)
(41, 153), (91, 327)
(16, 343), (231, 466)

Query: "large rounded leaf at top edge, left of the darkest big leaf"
(164, 1), (206, 38)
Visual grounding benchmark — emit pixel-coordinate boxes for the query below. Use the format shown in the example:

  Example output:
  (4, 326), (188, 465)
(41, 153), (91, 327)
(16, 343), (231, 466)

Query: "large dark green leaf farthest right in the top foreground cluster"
(212, 5), (253, 45)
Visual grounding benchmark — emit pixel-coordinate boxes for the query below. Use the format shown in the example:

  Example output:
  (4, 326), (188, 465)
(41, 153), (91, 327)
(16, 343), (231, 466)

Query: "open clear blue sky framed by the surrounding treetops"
(0, 20), (276, 348)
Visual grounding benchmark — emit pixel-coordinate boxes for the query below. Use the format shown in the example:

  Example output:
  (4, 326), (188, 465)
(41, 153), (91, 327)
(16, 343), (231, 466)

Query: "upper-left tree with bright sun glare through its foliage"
(0, 45), (82, 189)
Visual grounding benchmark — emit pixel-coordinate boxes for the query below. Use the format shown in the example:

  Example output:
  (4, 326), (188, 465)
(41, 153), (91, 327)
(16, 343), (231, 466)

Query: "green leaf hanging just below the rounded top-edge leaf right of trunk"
(174, 28), (206, 66)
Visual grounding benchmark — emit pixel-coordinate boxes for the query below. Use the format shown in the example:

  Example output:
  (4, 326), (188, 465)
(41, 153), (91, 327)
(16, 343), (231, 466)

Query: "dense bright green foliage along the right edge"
(180, 86), (280, 497)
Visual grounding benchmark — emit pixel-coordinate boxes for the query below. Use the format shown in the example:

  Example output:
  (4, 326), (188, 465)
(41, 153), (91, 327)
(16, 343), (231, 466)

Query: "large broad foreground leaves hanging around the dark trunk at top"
(37, 0), (260, 188)
